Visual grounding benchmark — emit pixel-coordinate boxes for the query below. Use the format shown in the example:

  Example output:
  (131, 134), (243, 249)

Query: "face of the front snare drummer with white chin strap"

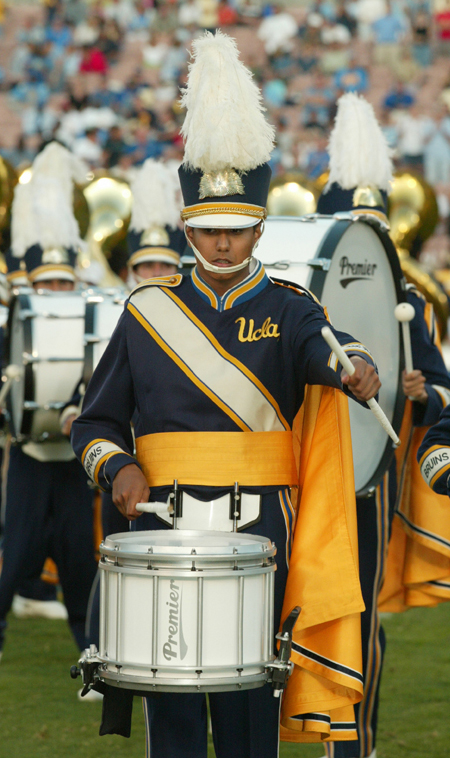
(186, 224), (261, 290)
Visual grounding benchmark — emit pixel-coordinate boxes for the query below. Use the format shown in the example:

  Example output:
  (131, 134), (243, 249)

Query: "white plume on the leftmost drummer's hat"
(11, 142), (88, 258)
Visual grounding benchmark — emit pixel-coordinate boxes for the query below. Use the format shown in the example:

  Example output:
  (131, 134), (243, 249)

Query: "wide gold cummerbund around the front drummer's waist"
(136, 432), (297, 487)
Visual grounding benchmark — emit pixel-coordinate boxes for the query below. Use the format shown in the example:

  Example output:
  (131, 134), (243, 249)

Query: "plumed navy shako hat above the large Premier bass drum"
(317, 92), (392, 216)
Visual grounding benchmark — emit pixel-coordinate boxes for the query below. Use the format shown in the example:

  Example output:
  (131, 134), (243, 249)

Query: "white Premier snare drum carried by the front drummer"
(98, 531), (276, 692)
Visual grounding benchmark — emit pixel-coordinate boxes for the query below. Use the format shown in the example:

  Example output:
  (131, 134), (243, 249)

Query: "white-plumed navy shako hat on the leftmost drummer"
(11, 142), (87, 284)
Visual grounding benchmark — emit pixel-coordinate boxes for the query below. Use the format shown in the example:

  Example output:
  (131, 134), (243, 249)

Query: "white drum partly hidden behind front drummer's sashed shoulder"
(83, 289), (127, 386)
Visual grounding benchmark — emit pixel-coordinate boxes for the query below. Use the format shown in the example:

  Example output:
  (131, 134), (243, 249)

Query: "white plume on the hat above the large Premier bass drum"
(325, 92), (392, 191)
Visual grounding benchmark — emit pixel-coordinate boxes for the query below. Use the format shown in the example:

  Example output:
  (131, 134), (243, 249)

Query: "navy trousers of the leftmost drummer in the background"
(0, 447), (97, 649)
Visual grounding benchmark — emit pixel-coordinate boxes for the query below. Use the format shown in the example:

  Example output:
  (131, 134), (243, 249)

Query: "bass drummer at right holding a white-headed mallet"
(317, 93), (450, 758)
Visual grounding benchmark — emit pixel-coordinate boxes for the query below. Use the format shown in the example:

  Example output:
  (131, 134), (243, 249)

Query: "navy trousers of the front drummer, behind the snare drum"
(134, 490), (293, 758)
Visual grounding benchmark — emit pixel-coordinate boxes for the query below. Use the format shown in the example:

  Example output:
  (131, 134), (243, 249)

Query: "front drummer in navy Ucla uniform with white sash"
(72, 32), (380, 758)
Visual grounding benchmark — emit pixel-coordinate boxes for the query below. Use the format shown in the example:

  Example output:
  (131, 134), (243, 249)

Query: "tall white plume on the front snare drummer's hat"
(181, 31), (275, 173)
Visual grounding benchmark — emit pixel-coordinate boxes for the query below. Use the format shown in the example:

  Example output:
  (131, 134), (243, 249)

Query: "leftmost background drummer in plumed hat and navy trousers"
(0, 143), (96, 664)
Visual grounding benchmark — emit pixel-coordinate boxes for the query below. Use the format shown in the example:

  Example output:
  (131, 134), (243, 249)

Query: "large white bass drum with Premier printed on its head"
(257, 213), (405, 496)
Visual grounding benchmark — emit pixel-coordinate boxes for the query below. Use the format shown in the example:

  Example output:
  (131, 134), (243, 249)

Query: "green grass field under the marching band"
(0, 604), (450, 758)
